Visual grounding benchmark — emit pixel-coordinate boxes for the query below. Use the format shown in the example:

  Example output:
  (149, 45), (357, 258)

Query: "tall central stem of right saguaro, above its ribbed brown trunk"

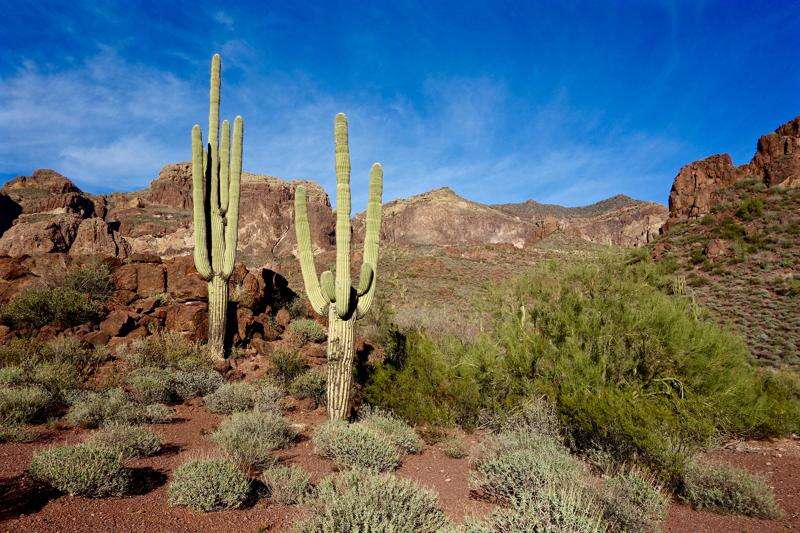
(334, 113), (352, 320)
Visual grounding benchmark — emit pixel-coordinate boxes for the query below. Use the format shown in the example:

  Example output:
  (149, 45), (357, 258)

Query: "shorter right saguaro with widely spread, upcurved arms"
(294, 113), (383, 420)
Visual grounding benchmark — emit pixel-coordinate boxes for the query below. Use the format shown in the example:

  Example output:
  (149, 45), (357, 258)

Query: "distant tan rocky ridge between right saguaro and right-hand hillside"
(355, 188), (667, 248)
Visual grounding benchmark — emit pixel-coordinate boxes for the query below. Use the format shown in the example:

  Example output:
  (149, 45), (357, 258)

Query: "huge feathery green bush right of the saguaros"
(366, 256), (800, 483)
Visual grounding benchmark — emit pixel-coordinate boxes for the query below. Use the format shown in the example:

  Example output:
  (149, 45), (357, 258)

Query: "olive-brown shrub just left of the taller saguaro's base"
(120, 332), (212, 370)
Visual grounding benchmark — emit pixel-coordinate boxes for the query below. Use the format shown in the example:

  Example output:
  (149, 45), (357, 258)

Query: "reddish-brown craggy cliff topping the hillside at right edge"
(666, 117), (800, 228)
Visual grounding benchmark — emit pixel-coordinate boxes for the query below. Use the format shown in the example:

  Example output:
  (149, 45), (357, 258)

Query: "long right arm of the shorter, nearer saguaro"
(357, 163), (383, 316)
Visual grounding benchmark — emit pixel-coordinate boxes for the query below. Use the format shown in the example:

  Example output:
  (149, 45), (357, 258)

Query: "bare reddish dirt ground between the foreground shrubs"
(0, 405), (800, 533)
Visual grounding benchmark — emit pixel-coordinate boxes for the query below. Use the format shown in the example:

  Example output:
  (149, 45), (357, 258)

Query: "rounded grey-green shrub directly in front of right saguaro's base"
(314, 420), (400, 472)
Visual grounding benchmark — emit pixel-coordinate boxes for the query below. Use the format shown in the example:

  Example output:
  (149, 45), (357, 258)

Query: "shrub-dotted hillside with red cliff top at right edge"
(652, 117), (800, 367)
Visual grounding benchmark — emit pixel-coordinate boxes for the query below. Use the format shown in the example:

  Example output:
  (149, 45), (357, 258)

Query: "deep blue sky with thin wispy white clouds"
(0, 0), (800, 209)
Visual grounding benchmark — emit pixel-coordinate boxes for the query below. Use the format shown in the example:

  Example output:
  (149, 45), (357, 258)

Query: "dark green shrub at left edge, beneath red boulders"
(0, 287), (100, 329)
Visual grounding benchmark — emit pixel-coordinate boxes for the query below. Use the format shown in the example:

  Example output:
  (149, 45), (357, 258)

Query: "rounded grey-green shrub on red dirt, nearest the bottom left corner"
(28, 444), (131, 498)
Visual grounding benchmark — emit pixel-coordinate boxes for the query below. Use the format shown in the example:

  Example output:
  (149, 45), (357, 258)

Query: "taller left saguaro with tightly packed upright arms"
(192, 54), (244, 359)
